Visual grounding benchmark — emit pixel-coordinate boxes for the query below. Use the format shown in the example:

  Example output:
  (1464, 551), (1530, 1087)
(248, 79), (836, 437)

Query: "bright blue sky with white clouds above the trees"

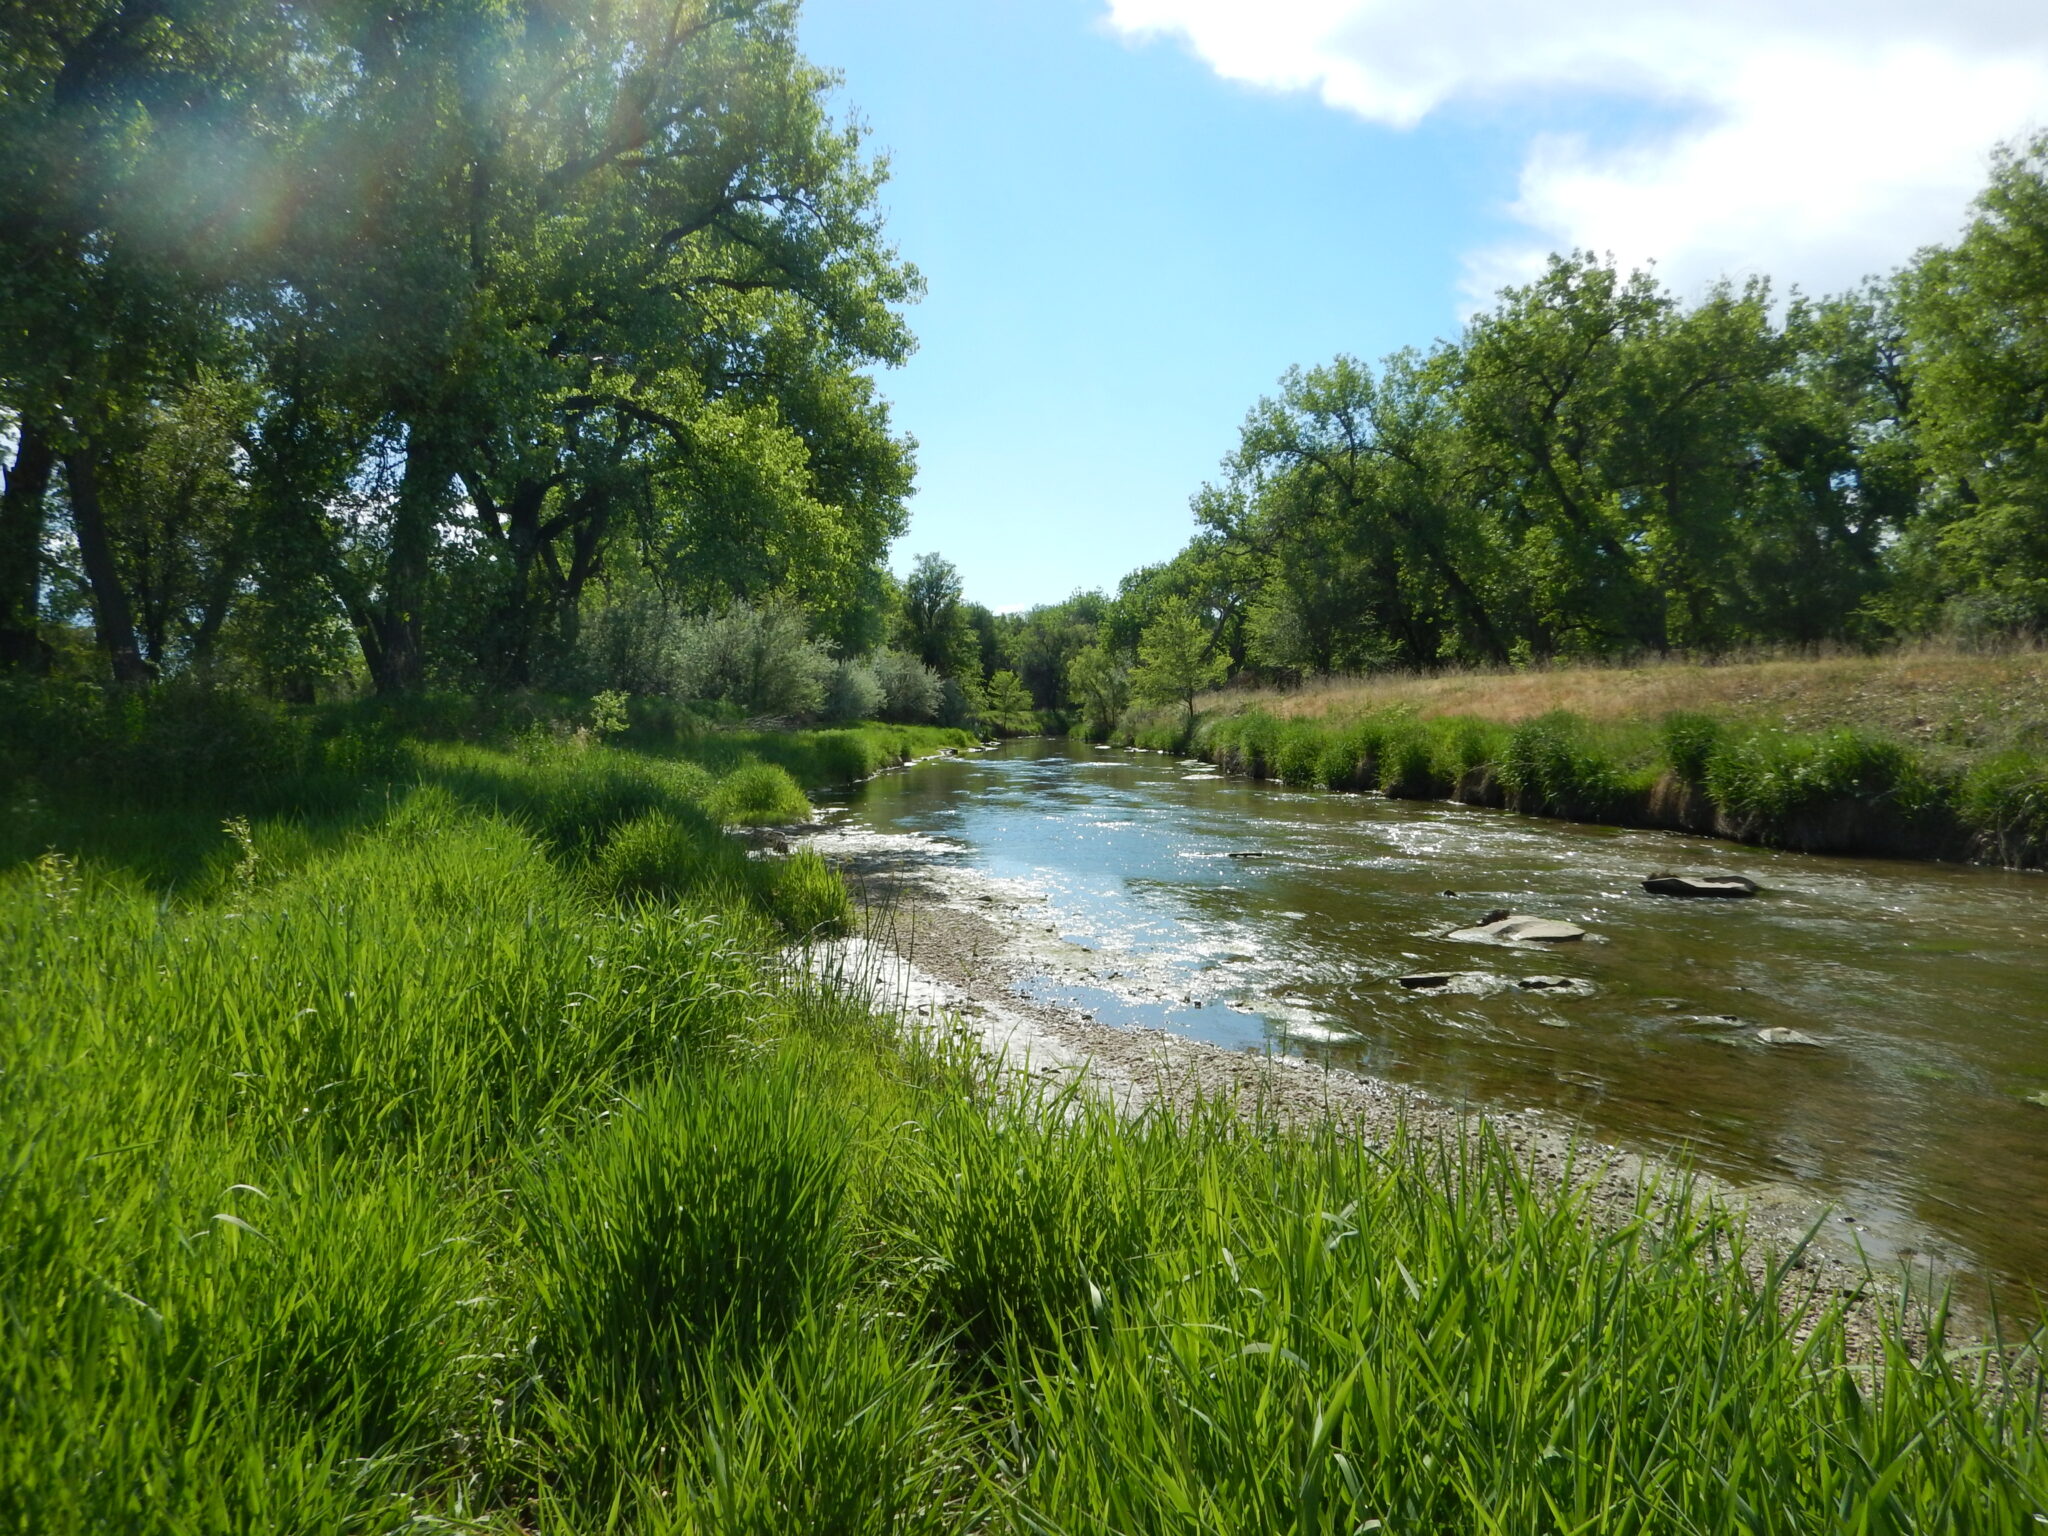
(801, 0), (2048, 610)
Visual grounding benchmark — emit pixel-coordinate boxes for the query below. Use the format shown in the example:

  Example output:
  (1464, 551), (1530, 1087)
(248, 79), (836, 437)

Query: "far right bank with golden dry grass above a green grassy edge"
(1122, 651), (2048, 868)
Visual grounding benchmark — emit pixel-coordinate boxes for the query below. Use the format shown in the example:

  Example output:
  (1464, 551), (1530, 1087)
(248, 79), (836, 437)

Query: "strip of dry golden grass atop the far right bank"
(1219, 647), (2048, 752)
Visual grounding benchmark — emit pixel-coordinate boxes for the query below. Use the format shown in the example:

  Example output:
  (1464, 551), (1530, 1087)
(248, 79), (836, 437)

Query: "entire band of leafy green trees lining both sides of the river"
(0, 0), (2048, 729)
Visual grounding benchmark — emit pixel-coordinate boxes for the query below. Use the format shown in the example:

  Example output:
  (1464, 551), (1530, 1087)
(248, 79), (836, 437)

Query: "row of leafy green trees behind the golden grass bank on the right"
(1018, 135), (2048, 723)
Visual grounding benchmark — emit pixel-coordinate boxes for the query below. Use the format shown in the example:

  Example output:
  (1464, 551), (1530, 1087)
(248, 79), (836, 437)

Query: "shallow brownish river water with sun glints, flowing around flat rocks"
(846, 739), (2048, 1300)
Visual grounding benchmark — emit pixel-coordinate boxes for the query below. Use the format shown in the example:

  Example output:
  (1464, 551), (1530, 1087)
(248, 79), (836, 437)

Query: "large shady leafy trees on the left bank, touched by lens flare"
(0, 0), (920, 698)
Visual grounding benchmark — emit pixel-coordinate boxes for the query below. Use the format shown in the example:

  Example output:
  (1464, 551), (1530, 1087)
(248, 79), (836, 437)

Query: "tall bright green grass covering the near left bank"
(0, 700), (2048, 1536)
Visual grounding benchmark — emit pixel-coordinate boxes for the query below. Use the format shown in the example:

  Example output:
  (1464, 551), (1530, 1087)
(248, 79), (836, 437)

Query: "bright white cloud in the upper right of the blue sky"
(1108, 0), (2048, 313)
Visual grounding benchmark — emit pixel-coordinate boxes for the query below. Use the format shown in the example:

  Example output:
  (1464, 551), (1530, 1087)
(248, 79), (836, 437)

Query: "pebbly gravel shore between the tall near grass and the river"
(807, 798), (1933, 1368)
